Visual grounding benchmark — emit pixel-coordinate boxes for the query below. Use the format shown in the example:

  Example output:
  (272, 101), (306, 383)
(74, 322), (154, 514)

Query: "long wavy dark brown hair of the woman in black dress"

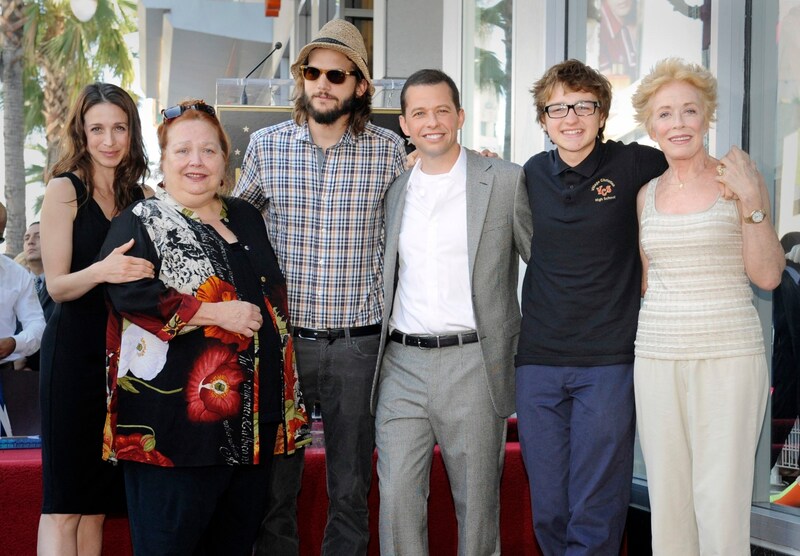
(47, 83), (147, 212)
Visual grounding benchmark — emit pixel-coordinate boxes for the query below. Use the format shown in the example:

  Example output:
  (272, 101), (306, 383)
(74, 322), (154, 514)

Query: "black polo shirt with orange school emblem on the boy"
(516, 141), (667, 367)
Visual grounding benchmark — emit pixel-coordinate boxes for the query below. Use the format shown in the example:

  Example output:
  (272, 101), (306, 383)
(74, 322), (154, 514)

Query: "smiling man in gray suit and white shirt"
(372, 70), (532, 556)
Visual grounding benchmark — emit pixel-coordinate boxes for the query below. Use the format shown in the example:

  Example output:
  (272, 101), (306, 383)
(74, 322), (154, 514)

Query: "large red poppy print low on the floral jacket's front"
(186, 342), (244, 423)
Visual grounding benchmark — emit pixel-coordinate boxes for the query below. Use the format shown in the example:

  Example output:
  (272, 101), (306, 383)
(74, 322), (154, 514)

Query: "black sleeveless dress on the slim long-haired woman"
(40, 173), (144, 515)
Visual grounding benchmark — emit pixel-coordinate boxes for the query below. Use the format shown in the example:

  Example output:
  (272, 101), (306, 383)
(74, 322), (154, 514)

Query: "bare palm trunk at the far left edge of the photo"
(0, 0), (25, 256)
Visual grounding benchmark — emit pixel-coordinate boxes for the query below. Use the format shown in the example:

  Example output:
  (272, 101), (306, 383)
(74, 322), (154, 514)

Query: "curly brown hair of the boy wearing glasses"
(530, 59), (611, 140)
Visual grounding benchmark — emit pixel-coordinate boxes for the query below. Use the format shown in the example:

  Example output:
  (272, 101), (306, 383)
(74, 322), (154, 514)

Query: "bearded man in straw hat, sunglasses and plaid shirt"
(234, 19), (405, 556)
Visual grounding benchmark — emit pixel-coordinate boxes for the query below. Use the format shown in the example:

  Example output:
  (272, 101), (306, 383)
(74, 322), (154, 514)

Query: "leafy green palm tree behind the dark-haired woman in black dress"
(24, 0), (136, 172)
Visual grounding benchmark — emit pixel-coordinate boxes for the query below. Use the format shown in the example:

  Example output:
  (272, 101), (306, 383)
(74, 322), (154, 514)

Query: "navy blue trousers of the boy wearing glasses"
(516, 364), (636, 556)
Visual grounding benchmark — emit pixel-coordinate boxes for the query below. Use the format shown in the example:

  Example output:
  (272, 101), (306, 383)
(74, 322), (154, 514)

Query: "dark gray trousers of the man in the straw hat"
(255, 335), (380, 556)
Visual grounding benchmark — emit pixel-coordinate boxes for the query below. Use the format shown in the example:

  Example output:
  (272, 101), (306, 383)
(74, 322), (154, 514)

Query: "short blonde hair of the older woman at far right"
(631, 58), (717, 131)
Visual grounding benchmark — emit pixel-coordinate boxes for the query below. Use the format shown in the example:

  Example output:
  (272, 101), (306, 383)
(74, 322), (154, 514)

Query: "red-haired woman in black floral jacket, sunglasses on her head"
(101, 100), (294, 556)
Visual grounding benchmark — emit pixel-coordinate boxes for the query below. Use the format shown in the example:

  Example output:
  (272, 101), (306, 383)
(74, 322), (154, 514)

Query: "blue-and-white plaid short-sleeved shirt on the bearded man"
(234, 121), (406, 328)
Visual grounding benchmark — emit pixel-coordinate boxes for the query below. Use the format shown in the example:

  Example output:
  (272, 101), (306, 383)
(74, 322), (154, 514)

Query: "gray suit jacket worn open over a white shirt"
(371, 150), (533, 417)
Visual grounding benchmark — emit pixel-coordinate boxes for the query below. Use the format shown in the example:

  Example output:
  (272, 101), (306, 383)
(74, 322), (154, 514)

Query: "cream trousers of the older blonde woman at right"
(634, 354), (769, 556)
